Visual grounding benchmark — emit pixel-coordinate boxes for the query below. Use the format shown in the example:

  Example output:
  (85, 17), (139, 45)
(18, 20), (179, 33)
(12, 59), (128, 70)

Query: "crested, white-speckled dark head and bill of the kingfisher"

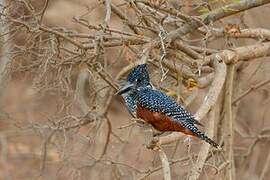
(116, 64), (151, 95)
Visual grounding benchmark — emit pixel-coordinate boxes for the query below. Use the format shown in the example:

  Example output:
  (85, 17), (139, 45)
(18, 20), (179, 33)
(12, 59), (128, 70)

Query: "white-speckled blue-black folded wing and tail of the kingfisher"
(137, 88), (218, 147)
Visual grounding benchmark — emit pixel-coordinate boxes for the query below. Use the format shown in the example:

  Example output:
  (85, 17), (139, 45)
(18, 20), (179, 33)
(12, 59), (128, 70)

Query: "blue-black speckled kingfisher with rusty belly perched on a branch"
(116, 64), (219, 148)
